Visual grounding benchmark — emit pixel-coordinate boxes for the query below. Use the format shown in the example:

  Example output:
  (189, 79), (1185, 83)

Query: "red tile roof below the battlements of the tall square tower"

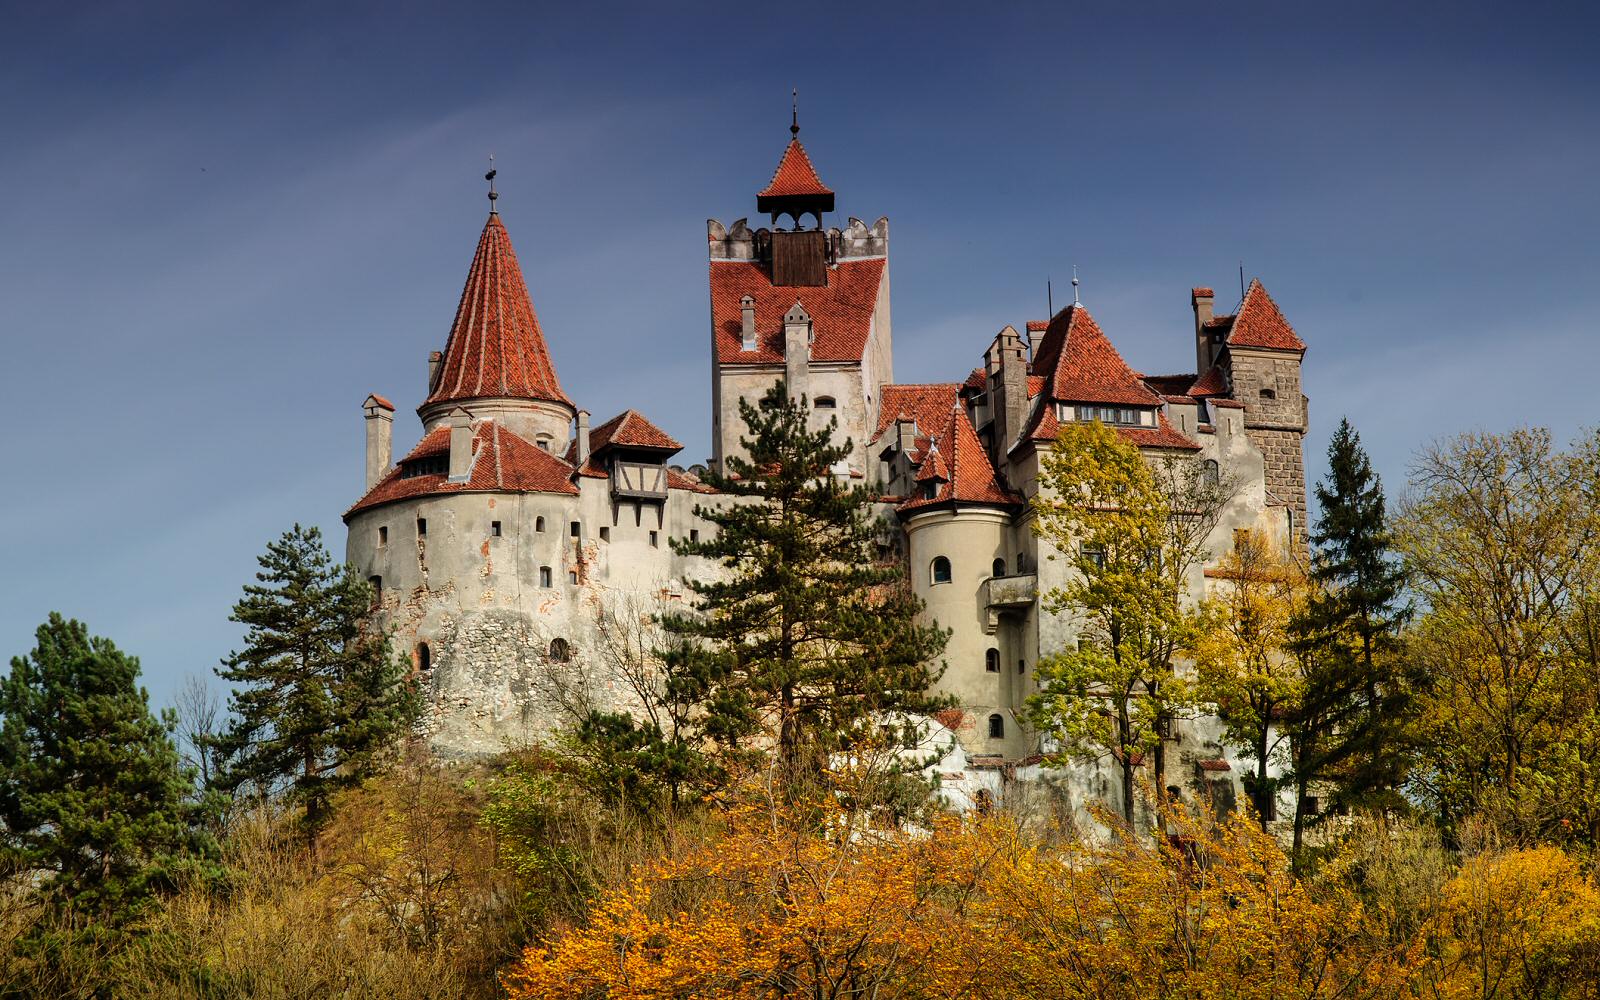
(710, 258), (883, 365)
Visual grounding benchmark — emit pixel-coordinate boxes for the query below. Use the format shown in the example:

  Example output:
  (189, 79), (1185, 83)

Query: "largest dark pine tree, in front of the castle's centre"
(662, 382), (949, 782)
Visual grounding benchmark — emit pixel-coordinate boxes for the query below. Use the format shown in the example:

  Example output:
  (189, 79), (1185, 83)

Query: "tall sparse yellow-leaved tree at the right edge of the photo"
(1398, 430), (1600, 846)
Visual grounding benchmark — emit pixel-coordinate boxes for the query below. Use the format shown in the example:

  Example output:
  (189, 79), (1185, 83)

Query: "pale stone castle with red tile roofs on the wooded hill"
(344, 120), (1307, 816)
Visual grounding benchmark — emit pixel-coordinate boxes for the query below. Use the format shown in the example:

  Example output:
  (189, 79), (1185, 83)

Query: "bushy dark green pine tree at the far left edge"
(0, 614), (206, 923)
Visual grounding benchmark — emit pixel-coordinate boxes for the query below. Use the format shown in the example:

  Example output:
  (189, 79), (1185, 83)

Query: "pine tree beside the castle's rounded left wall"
(216, 525), (421, 843)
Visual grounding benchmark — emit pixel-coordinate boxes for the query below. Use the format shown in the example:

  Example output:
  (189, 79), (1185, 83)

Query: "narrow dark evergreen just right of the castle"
(1290, 419), (1410, 840)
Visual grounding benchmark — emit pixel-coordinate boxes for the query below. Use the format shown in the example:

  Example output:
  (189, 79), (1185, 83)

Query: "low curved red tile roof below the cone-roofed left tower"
(344, 421), (578, 518)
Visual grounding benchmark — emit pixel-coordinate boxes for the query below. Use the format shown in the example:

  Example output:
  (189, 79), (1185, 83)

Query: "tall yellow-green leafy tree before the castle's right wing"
(1029, 421), (1230, 822)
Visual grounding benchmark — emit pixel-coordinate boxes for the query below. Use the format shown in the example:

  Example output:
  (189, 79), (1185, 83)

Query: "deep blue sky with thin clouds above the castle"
(0, 3), (1600, 701)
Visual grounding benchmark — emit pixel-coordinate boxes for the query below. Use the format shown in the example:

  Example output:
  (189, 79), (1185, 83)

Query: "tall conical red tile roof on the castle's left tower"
(424, 214), (571, 406)
